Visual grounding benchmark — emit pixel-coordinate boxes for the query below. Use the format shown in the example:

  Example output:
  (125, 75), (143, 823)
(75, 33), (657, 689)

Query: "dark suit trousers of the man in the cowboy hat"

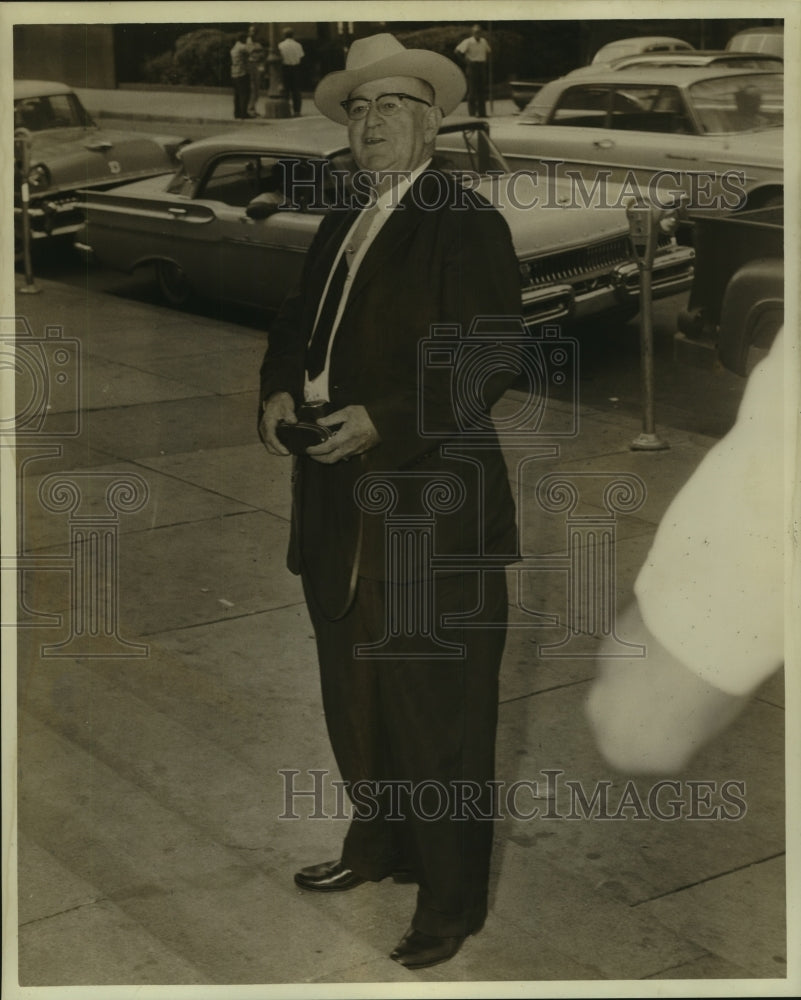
(306, 570), (508, 937)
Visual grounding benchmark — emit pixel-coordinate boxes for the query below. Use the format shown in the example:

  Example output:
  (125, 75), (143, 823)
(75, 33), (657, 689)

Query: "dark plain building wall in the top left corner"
(14, 24), (117, 88)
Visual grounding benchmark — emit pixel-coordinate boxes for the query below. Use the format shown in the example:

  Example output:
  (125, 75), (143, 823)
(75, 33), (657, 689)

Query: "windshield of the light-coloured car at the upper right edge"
(689, 73), (784, 133)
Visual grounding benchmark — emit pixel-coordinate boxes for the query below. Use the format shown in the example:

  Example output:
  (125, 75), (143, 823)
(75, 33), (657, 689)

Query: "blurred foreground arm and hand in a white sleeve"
(587, 333), (801, 774)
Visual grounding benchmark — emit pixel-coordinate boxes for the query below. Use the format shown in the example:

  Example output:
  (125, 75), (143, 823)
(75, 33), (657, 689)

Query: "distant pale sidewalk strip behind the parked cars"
(76, 87), (518, 127)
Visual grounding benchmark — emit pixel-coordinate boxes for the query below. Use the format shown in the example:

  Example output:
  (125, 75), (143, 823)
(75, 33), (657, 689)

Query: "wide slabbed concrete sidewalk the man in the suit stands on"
(10, 268), (787, 996)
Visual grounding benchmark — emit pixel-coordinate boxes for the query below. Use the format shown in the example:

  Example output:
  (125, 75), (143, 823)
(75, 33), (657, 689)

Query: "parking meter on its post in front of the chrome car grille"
(626, 198), (676, 451)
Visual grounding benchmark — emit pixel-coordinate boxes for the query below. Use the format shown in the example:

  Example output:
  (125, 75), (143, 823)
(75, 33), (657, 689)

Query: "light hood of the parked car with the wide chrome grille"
(478, 172), (629, 259)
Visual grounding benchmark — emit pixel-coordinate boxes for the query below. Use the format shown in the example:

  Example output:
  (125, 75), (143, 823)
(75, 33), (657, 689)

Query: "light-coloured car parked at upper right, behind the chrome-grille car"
(492, 65), (784, 209)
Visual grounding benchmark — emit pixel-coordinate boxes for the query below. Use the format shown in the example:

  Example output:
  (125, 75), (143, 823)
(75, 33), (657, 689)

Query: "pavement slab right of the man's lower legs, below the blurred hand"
(490, 684), (785, 908)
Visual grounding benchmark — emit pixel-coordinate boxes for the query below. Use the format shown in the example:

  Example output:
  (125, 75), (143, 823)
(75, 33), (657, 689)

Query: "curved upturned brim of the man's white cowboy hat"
(314, 49), (467, 125)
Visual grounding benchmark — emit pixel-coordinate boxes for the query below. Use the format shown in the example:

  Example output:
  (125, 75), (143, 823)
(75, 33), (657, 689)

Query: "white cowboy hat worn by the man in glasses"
(314, 34), (467, 125)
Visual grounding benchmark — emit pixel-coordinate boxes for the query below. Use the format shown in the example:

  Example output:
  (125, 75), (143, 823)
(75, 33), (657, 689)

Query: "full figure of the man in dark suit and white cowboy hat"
(259, 35), (521, 968)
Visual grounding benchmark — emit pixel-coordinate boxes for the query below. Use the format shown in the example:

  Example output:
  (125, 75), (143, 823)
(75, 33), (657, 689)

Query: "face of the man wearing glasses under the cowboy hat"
(348, 76), (441, 171)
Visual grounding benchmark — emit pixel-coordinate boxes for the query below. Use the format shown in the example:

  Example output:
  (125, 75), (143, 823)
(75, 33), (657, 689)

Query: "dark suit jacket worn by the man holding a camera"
(261, 169), (522, 618)
